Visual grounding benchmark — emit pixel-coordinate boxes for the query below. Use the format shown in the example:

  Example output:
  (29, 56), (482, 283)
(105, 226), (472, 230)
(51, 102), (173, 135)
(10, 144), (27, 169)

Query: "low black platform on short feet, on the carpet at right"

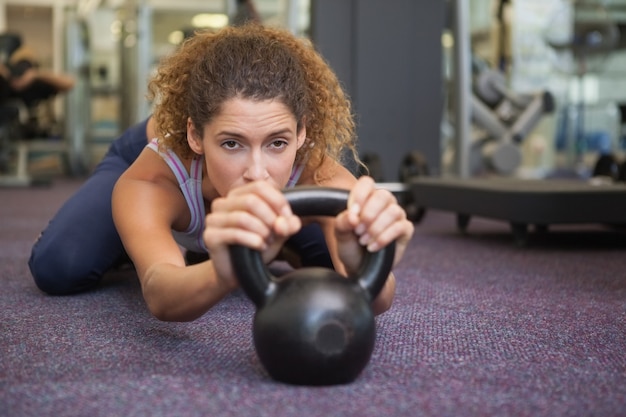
(409, 177), (626, 246)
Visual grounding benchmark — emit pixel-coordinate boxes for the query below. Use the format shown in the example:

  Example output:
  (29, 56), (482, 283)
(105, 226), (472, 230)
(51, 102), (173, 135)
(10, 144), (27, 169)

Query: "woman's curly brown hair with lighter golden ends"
(148, 23), (359, 179)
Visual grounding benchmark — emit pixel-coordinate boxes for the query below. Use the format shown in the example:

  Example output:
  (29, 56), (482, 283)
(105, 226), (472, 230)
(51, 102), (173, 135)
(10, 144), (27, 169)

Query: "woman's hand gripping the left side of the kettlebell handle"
(203, 181), (302, 288)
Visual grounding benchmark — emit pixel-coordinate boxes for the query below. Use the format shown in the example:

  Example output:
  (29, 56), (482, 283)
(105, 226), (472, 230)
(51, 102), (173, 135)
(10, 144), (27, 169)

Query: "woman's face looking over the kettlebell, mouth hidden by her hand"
(187, 98), (306, 196)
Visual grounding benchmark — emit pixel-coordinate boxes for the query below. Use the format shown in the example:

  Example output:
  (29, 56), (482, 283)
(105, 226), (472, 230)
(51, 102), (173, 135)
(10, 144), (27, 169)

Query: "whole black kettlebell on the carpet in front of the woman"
(229, 186), (395, 385)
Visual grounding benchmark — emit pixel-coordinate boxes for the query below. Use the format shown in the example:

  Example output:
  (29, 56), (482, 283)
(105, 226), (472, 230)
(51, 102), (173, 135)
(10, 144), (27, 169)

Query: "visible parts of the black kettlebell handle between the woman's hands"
(229, 186), (395, 307)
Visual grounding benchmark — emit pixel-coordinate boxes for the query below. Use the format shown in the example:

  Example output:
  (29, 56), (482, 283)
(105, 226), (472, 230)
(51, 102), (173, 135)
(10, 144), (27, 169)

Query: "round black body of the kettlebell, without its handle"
(253, 268), (376, 385)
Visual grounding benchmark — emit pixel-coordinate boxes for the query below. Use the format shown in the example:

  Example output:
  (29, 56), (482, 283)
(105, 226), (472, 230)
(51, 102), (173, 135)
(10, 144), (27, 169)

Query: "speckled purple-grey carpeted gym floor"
(0, 179), (626, 417)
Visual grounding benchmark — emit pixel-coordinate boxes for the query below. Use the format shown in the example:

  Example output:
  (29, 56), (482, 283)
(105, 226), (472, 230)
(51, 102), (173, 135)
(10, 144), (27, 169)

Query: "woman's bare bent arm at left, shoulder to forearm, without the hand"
(113, 150), (234, 321)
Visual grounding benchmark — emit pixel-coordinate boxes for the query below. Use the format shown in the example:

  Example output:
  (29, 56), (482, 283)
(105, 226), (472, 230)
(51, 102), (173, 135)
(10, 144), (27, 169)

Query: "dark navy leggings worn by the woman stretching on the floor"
(28, 120), (332, 295)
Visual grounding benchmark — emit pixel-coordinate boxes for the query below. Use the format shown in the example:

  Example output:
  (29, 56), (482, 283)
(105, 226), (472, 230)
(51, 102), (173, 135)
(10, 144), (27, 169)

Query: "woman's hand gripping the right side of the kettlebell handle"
(335, 176), (414, 273)
